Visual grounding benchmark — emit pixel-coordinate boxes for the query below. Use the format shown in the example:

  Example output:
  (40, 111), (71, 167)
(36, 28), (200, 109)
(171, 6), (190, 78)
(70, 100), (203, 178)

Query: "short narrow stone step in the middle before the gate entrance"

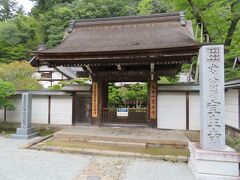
(87, 140), (146, 148)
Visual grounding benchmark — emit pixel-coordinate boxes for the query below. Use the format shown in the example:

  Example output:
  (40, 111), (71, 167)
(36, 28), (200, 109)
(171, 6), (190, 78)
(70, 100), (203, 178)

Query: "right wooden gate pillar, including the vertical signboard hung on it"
(148, 81), (157, 128)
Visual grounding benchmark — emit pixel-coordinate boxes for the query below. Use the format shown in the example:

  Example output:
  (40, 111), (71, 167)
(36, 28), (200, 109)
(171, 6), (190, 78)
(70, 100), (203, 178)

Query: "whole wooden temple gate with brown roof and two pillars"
(31, 12), (201, 127)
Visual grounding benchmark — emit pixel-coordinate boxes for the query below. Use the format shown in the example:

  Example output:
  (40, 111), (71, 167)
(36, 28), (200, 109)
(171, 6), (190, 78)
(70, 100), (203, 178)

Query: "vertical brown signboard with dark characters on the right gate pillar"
(149, 82), (157, 119)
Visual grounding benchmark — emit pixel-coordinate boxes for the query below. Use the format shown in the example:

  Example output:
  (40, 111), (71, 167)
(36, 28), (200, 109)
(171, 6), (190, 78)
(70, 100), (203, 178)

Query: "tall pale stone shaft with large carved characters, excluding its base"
(199, 45), (225, 150)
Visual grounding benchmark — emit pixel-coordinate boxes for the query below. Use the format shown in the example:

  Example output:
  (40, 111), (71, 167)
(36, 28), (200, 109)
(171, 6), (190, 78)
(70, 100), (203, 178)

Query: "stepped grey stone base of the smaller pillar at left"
(12, 128), (38, 139)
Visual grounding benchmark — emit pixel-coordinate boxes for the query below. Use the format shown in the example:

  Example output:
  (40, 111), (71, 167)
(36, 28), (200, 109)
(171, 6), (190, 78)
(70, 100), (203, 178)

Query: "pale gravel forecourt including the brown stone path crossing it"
(0, 137), (194, 180)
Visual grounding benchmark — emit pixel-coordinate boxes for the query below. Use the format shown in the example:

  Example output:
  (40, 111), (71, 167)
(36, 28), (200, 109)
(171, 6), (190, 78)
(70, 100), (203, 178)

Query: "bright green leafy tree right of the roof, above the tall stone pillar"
(169, 0), (240, 79)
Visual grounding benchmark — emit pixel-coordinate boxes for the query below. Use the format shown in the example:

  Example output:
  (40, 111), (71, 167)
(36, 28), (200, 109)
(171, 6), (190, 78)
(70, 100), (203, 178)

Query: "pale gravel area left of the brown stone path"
(0, 137), (89, 180)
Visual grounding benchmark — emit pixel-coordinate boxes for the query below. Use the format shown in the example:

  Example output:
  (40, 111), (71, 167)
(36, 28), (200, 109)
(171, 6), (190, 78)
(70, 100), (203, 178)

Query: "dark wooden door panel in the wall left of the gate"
(75, 96), (91, 123)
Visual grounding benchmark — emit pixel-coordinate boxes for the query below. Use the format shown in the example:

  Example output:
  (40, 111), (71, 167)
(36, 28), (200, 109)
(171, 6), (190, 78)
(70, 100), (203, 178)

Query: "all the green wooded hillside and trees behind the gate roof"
(0, 0), (240, 83)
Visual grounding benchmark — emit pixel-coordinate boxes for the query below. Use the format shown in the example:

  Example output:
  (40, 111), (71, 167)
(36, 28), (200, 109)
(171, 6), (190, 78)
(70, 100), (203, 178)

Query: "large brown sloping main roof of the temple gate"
(31, 13), (201, 66)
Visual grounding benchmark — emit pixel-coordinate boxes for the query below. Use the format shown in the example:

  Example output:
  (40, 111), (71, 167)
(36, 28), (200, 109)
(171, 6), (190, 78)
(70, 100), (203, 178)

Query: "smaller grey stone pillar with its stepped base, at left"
(12, 93), (38, 139)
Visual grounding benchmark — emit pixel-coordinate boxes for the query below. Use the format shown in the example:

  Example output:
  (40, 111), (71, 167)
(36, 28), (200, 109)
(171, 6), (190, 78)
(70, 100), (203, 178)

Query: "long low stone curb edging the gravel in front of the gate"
(31, 145), (188, 163)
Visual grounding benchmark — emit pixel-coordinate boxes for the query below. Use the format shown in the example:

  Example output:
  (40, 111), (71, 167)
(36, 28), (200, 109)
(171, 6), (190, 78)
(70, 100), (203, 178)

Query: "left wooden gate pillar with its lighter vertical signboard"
(92, 81), (103, 126)
